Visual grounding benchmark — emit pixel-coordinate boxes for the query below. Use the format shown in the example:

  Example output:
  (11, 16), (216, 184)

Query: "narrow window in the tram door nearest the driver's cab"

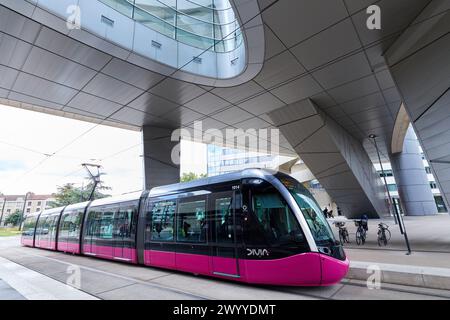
(214, 197), (234, 243)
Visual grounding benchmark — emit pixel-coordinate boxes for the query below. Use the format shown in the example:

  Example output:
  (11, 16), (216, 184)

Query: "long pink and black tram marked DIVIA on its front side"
(22, 169), (349, 286)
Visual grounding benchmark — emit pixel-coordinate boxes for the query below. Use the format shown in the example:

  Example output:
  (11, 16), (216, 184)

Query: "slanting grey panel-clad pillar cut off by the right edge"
(386, 0), (450, 213)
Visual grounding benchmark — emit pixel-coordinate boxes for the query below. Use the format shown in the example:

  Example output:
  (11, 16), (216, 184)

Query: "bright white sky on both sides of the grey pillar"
(0, 105), (206, 195)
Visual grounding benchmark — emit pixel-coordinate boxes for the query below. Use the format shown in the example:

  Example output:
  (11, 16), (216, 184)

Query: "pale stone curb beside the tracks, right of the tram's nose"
(346, 261), (450, 290)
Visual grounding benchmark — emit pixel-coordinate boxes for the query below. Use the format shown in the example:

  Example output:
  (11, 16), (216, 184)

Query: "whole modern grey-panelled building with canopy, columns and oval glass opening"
(0, 0), (450, 217)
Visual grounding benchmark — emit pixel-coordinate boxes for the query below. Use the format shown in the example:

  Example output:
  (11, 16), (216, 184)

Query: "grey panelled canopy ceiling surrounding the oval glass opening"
(0, 0), (445, 216)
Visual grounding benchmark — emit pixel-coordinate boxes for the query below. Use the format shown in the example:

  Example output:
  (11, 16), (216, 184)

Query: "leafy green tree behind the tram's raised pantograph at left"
(50, 183), (111, 208)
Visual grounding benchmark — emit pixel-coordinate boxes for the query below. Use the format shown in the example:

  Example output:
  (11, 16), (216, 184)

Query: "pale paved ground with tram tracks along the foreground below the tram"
(0, 237), (450, 300)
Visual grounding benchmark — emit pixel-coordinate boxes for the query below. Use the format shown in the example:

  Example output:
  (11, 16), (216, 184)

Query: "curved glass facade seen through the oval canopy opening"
(100, 0), (243, 52)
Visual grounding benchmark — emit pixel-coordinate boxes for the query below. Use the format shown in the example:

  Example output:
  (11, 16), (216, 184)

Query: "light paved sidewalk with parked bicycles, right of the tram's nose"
(329, 214), (450, 290)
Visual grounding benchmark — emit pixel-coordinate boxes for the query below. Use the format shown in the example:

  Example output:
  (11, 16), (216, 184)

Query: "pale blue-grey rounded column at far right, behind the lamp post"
(391, 126), (437, 216)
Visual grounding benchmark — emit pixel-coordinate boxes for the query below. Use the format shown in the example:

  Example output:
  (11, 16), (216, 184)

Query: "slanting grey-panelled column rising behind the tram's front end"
(269, 99), (387, 218)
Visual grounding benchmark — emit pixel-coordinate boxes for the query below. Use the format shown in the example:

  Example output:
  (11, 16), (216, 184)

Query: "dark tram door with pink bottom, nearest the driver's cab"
(209, 191), (240, 278)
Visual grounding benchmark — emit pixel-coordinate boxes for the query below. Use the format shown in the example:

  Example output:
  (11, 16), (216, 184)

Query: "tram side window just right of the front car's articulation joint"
(150, 200), (176, 241)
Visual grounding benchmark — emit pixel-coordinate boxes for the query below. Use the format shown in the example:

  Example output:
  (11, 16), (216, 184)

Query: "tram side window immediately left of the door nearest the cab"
(177, 200), (206, 243)
